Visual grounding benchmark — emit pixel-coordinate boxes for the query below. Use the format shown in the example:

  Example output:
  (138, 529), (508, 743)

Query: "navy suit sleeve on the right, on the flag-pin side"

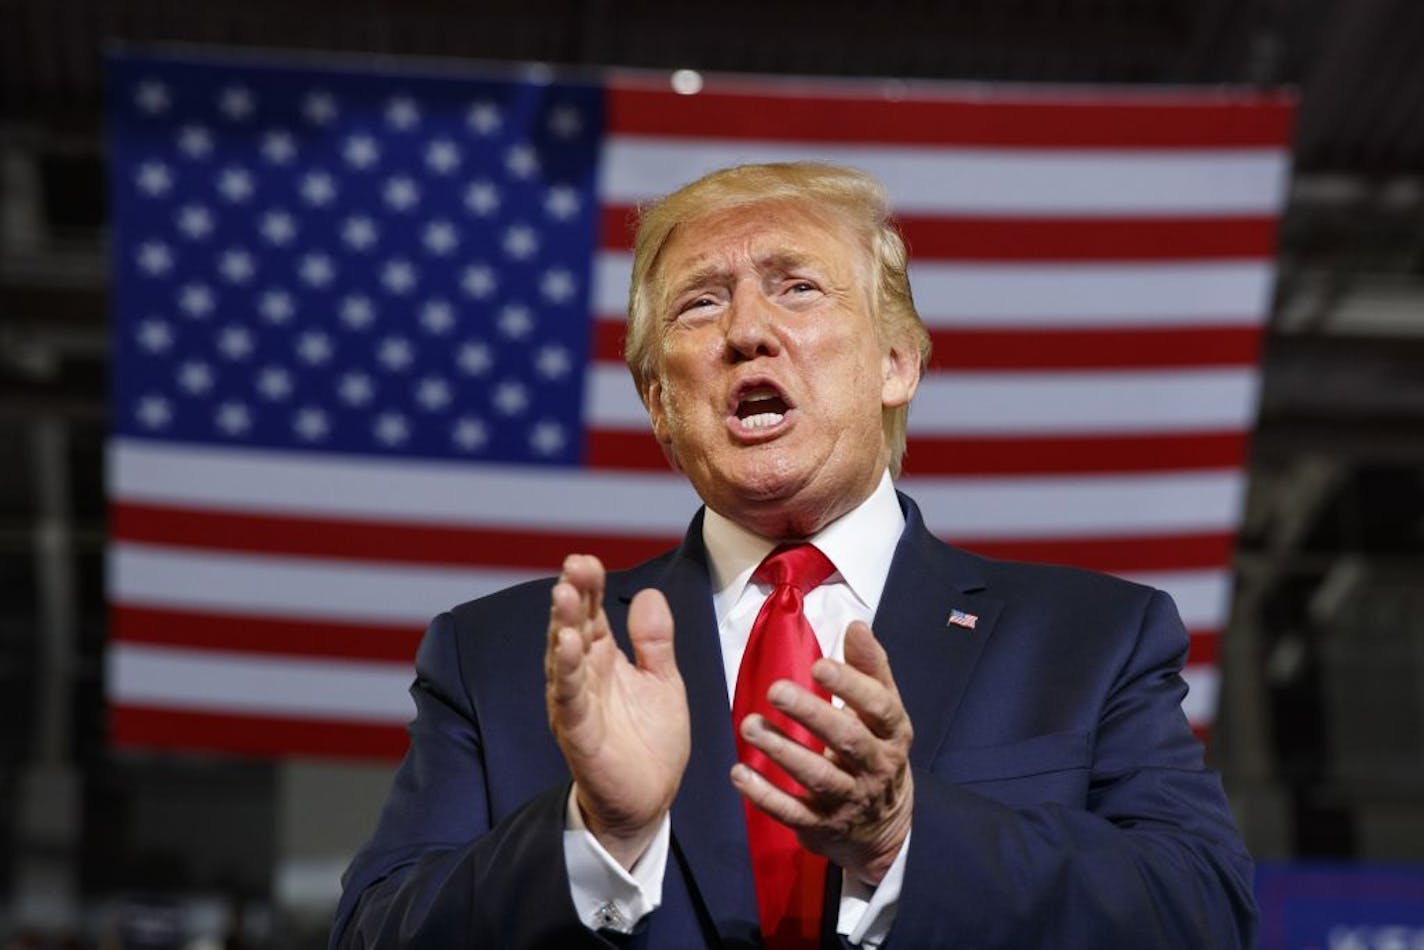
(886, 591), (1256, 950)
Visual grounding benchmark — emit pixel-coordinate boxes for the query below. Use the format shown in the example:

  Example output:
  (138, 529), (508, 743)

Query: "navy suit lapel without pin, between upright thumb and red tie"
(609, 513), (758, 946)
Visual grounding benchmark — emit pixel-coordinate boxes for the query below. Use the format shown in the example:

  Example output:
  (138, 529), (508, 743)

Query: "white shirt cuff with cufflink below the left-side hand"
(564, 786), (672, 933)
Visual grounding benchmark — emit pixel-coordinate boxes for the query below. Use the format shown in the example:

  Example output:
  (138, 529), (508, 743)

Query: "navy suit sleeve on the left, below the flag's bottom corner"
(330, 614), (626, 950)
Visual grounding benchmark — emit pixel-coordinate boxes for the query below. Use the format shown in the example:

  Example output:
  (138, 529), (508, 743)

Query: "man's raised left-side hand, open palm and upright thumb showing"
(544, 554), (692, 867)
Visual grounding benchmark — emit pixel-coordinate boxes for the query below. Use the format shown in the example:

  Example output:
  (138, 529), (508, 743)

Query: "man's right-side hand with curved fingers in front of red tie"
(732, 621), (914, 884)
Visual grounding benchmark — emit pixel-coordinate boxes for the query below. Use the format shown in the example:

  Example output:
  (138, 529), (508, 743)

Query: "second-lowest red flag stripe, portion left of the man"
(110, 604), (422, 662)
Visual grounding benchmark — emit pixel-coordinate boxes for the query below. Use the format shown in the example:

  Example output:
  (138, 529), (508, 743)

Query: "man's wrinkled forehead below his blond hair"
(656, 201), (864, 281)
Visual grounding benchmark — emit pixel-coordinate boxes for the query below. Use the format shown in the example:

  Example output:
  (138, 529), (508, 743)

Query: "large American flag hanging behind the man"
(108, 56), (1292, 758)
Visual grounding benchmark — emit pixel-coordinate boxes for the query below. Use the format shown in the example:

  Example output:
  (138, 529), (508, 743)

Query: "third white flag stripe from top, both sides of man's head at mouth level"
(585, 363), (1259, 439)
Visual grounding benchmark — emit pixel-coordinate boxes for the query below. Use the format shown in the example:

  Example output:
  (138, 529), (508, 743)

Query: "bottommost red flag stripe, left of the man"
(108, 705), (407, 759)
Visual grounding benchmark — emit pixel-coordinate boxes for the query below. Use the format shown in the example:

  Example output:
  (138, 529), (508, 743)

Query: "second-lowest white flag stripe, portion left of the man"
(108, 541), (541, 627)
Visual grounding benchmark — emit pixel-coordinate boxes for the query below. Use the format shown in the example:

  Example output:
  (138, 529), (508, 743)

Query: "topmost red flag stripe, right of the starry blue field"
(607, 80), (1294, 150)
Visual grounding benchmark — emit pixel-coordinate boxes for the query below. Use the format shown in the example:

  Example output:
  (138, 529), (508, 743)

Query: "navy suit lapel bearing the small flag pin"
(874, 494), (1004, 768)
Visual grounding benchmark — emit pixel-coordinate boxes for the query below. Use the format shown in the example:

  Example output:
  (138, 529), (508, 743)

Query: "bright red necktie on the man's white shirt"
(732, 544), (836, 950)
